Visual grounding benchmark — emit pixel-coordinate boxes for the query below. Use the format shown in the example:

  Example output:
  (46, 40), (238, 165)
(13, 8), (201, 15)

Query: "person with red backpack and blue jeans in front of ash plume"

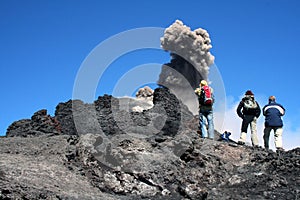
(195, 80), (214, 139)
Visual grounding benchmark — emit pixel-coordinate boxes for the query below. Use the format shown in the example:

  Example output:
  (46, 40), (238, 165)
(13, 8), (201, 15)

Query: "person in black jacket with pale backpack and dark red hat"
(236, 90), (261, 147)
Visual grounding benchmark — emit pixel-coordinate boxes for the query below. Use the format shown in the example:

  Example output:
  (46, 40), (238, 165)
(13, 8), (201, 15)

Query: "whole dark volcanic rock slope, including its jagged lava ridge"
(0, 88), (300, 200)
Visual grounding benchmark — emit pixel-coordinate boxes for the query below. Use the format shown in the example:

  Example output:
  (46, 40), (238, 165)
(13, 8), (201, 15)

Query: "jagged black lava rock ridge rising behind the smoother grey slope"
(6, 88), (193, 137)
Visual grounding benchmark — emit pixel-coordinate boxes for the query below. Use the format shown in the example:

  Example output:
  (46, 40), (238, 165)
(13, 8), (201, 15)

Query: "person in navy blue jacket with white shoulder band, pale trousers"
(263, 96), (285, 151)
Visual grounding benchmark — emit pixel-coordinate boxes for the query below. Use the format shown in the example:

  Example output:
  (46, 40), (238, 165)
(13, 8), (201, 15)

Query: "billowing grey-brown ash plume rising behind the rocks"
(157, 20), (214, 113)
